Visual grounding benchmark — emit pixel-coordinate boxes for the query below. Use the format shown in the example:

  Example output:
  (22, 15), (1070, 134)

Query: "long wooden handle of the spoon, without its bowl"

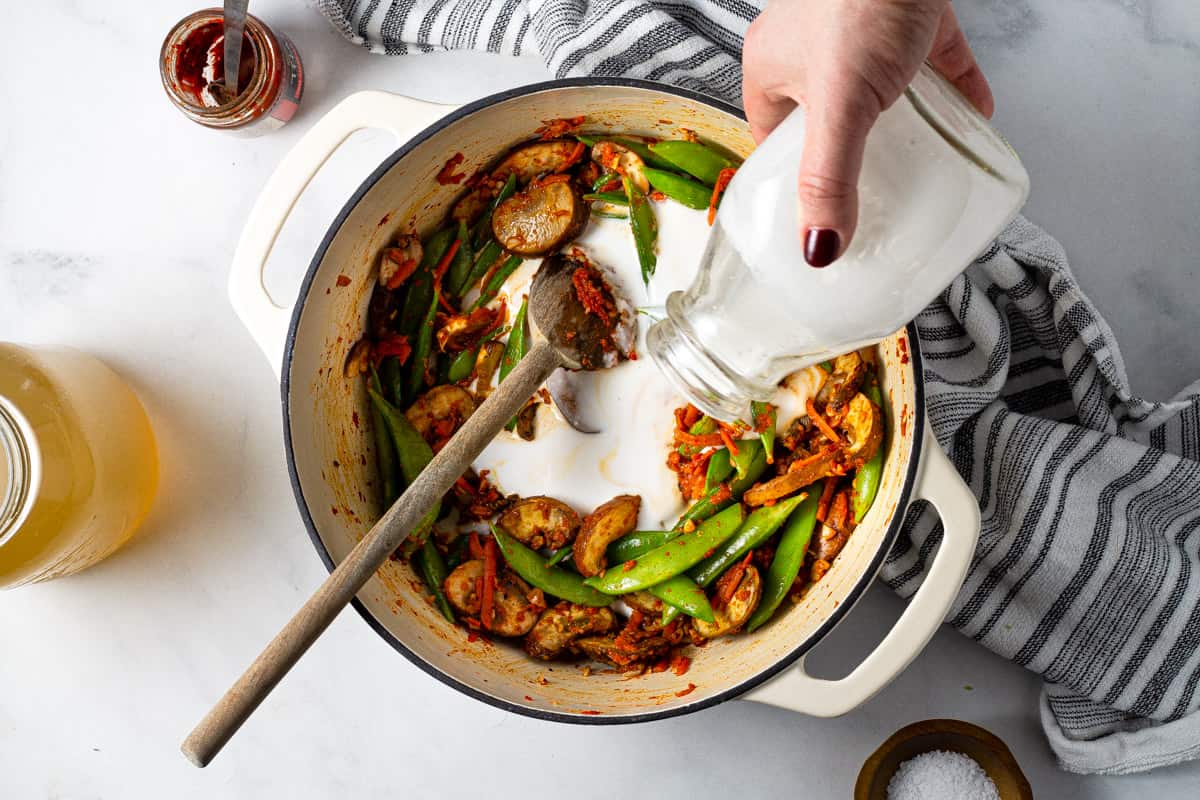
(181, 341), (560, 766)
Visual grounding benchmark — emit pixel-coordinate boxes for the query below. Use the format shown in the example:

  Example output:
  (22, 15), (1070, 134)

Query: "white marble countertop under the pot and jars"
(0, 0), (1200, 800)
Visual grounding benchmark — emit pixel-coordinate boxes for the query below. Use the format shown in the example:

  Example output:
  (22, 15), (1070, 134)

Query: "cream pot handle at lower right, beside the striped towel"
(742, 421), (979, 717)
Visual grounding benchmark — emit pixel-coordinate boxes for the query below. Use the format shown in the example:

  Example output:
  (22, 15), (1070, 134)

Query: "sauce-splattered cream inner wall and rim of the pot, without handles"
(284, 84), (920, 722)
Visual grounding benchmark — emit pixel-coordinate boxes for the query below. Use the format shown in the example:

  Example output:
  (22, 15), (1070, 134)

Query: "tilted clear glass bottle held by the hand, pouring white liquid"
(647, 66), (1030, 421)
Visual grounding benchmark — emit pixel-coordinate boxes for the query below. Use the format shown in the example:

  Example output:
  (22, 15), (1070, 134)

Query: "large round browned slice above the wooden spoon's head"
(492, 175), (589, 255)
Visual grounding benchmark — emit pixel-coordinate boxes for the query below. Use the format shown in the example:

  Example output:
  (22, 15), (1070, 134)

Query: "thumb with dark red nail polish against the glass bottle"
(799, 92), (880, 266)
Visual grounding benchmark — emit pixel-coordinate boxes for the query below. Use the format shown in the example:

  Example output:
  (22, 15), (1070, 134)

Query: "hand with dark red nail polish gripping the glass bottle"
(742, 0), (992, 266)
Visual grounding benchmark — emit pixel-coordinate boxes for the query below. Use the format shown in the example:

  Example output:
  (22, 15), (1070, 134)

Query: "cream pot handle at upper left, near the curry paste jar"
(229, 91), (456, 377)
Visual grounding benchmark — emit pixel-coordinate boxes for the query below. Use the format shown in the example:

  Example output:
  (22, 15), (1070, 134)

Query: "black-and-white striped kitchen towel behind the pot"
(318, 0), (1200, 772)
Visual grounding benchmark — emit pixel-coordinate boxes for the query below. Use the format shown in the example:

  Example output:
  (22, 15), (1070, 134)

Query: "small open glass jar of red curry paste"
(158, 8), (304, 136)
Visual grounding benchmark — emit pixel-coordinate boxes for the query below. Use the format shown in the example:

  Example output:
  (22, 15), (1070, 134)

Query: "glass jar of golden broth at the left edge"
(0, 343), (158, 588)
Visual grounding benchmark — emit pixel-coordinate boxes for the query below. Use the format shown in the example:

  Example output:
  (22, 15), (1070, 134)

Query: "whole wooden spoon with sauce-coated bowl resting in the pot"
(182, 255), (636, 766)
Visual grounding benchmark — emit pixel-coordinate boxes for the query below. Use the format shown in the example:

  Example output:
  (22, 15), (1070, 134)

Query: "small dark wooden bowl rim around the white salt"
(854, 720), (1033, 800)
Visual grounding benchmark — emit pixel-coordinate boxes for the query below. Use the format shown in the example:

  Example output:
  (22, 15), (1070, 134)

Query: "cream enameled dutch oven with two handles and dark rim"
(229, 78), (979, 723)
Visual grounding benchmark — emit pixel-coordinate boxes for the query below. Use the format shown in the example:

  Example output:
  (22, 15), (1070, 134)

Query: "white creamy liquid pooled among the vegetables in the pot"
(474, 200), (820, 530)
